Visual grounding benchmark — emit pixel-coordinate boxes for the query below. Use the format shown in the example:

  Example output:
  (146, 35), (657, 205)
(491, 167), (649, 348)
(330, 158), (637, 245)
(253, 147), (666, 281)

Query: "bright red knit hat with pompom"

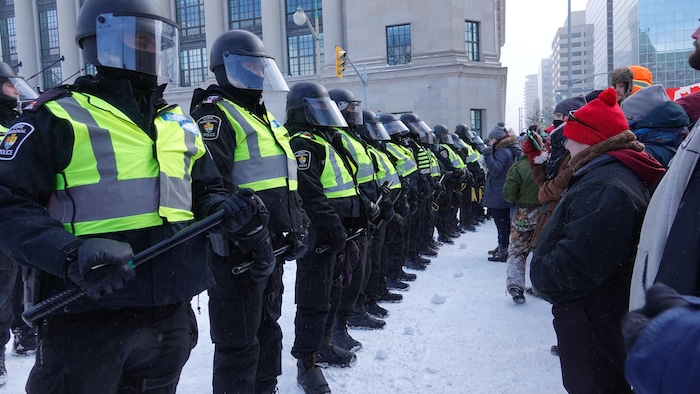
(564, 88), (629, 145)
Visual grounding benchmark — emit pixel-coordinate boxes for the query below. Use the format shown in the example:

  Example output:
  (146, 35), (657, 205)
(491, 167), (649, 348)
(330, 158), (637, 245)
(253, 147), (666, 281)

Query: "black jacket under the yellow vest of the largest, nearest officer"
(0, 77), (227, 312)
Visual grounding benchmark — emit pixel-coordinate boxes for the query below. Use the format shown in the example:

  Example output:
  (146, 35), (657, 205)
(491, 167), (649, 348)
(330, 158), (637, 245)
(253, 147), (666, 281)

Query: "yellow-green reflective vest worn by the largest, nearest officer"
(45, 92), (205, 235)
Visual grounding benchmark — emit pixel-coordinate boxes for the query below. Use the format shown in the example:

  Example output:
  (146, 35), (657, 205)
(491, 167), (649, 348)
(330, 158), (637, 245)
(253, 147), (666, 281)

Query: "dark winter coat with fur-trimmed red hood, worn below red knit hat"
(530, 131), (663, 304)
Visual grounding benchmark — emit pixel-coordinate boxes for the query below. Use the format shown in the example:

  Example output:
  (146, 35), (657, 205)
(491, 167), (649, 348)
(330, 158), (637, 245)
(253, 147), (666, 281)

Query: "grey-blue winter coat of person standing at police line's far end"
(481, 136), (522, 209)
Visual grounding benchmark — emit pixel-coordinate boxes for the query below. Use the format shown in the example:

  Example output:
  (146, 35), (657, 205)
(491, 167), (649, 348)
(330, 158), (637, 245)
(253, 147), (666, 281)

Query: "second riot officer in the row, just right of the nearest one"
(192, 30), (308, 394)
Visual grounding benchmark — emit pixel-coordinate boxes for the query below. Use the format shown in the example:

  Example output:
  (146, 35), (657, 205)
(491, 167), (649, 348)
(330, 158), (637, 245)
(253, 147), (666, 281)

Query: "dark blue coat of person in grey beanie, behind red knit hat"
(631, 101), (690, 168)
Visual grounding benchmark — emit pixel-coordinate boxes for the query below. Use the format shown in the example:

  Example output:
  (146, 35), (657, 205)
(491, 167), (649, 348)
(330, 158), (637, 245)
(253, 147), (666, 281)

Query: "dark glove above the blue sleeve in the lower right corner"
(622, 283), (688, 352)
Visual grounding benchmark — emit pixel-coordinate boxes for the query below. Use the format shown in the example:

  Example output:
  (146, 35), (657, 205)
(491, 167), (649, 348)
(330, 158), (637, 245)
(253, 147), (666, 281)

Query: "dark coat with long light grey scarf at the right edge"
(630, 123), (700, 309)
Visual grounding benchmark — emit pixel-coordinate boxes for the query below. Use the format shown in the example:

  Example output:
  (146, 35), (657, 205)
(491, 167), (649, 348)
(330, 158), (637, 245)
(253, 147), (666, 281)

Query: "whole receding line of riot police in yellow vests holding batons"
(0, 0), (483, 393)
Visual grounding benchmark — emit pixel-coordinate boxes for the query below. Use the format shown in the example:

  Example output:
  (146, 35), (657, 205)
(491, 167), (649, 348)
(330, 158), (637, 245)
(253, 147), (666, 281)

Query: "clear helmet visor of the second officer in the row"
(224, 52), (289, 92)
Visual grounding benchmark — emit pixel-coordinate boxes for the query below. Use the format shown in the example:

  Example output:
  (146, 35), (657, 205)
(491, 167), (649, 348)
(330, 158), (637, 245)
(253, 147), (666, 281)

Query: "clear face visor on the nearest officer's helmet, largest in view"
(96, 14), (178, 83)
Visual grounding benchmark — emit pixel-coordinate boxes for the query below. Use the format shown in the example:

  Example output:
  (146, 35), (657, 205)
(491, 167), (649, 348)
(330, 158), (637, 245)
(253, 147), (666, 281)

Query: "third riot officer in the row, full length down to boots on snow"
(285, 82), (366, 393)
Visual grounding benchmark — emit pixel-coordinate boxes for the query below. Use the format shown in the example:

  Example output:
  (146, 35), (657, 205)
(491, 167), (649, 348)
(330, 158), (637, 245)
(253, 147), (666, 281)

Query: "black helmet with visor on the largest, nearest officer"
(75, 0), (179, 82)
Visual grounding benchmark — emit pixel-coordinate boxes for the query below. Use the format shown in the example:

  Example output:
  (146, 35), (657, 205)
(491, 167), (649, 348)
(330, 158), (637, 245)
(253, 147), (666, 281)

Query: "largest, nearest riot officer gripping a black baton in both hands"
(0, 0), (266, 394)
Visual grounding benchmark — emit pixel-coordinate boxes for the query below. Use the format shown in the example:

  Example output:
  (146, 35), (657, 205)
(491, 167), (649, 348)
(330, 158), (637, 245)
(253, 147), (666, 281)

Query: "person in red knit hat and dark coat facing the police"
(530, 88), (664, 393)
